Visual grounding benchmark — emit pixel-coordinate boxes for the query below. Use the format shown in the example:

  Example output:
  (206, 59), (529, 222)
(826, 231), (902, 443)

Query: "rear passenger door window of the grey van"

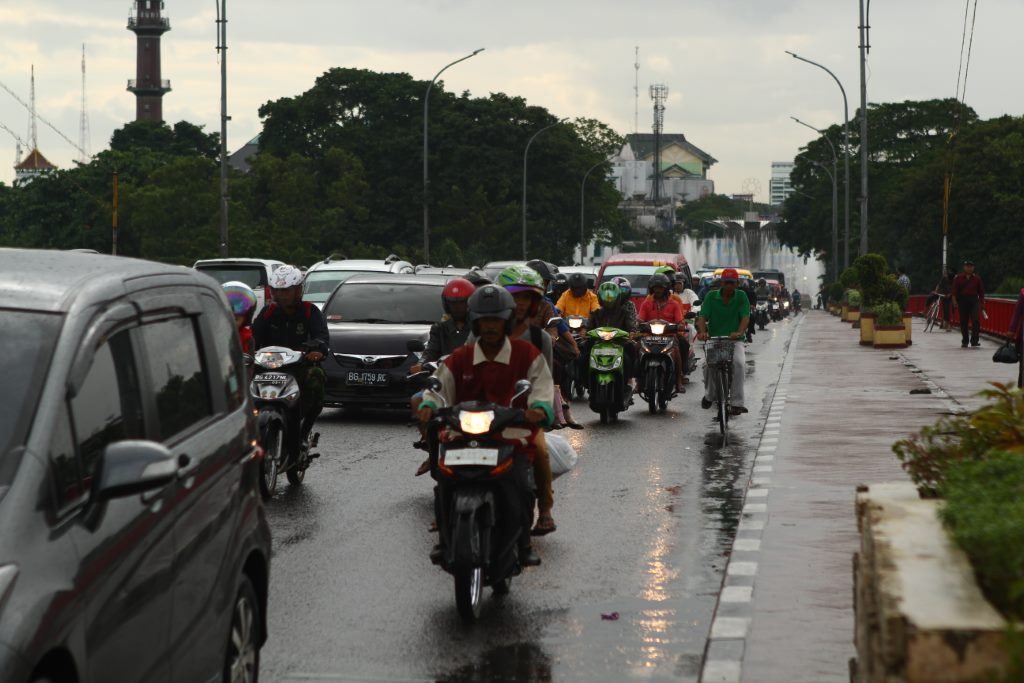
(139, 317), (213, 441)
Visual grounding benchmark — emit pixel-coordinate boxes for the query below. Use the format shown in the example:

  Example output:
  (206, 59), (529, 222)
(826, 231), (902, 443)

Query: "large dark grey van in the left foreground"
(0, 249), (270, 683)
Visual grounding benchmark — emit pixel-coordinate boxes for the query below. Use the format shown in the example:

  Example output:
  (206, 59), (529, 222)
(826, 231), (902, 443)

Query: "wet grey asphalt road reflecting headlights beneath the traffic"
(262, 321), (793, 682)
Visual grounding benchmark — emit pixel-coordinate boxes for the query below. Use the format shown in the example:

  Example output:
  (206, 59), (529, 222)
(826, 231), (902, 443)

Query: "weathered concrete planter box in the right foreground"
(852, 481), (1009, 683)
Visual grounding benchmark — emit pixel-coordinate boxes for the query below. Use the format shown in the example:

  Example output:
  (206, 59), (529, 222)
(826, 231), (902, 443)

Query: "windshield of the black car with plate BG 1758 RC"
(324, 283), (444, 325)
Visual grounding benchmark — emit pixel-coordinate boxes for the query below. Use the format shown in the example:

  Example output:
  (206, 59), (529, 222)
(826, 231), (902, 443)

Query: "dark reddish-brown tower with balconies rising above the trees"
(127, 0), (171, 121)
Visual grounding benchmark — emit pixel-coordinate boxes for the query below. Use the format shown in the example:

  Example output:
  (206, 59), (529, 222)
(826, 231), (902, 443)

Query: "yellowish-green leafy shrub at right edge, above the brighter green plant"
(893, 383), (1024, 496)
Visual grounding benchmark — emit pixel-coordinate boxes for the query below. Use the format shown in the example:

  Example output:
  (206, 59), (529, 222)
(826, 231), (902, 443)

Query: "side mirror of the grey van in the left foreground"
(93, 440), (178, 501)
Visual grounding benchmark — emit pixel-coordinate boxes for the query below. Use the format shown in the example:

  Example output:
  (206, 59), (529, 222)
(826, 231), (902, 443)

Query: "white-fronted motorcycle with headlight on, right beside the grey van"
(249, 346), (319, 498)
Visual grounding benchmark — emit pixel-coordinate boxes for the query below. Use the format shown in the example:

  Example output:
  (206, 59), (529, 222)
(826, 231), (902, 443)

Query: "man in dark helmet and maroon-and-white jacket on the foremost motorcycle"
(419, 285), (555, 566)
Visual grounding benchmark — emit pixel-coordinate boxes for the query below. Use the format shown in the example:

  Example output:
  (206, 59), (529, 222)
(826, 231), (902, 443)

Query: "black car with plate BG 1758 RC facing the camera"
(324, 274), (449, 408)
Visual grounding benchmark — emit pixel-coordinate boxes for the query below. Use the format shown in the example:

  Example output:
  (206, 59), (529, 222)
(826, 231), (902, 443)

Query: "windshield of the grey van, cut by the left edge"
(0, 308), (62, 462)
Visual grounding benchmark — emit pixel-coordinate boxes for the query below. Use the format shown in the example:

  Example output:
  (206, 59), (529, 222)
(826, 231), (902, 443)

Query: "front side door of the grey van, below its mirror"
(67, 326), (175, 683)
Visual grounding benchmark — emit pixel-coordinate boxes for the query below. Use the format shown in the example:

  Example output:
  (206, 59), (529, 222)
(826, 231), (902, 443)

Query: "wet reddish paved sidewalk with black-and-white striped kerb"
(702, 311), (1017, 683)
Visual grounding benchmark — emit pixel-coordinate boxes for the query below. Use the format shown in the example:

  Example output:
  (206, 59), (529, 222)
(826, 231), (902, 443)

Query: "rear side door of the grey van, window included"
(136, 288), (251, 683)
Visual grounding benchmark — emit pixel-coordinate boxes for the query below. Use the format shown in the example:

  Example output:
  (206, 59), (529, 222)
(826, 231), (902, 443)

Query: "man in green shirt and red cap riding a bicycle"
(697, 268), (751, 415)
